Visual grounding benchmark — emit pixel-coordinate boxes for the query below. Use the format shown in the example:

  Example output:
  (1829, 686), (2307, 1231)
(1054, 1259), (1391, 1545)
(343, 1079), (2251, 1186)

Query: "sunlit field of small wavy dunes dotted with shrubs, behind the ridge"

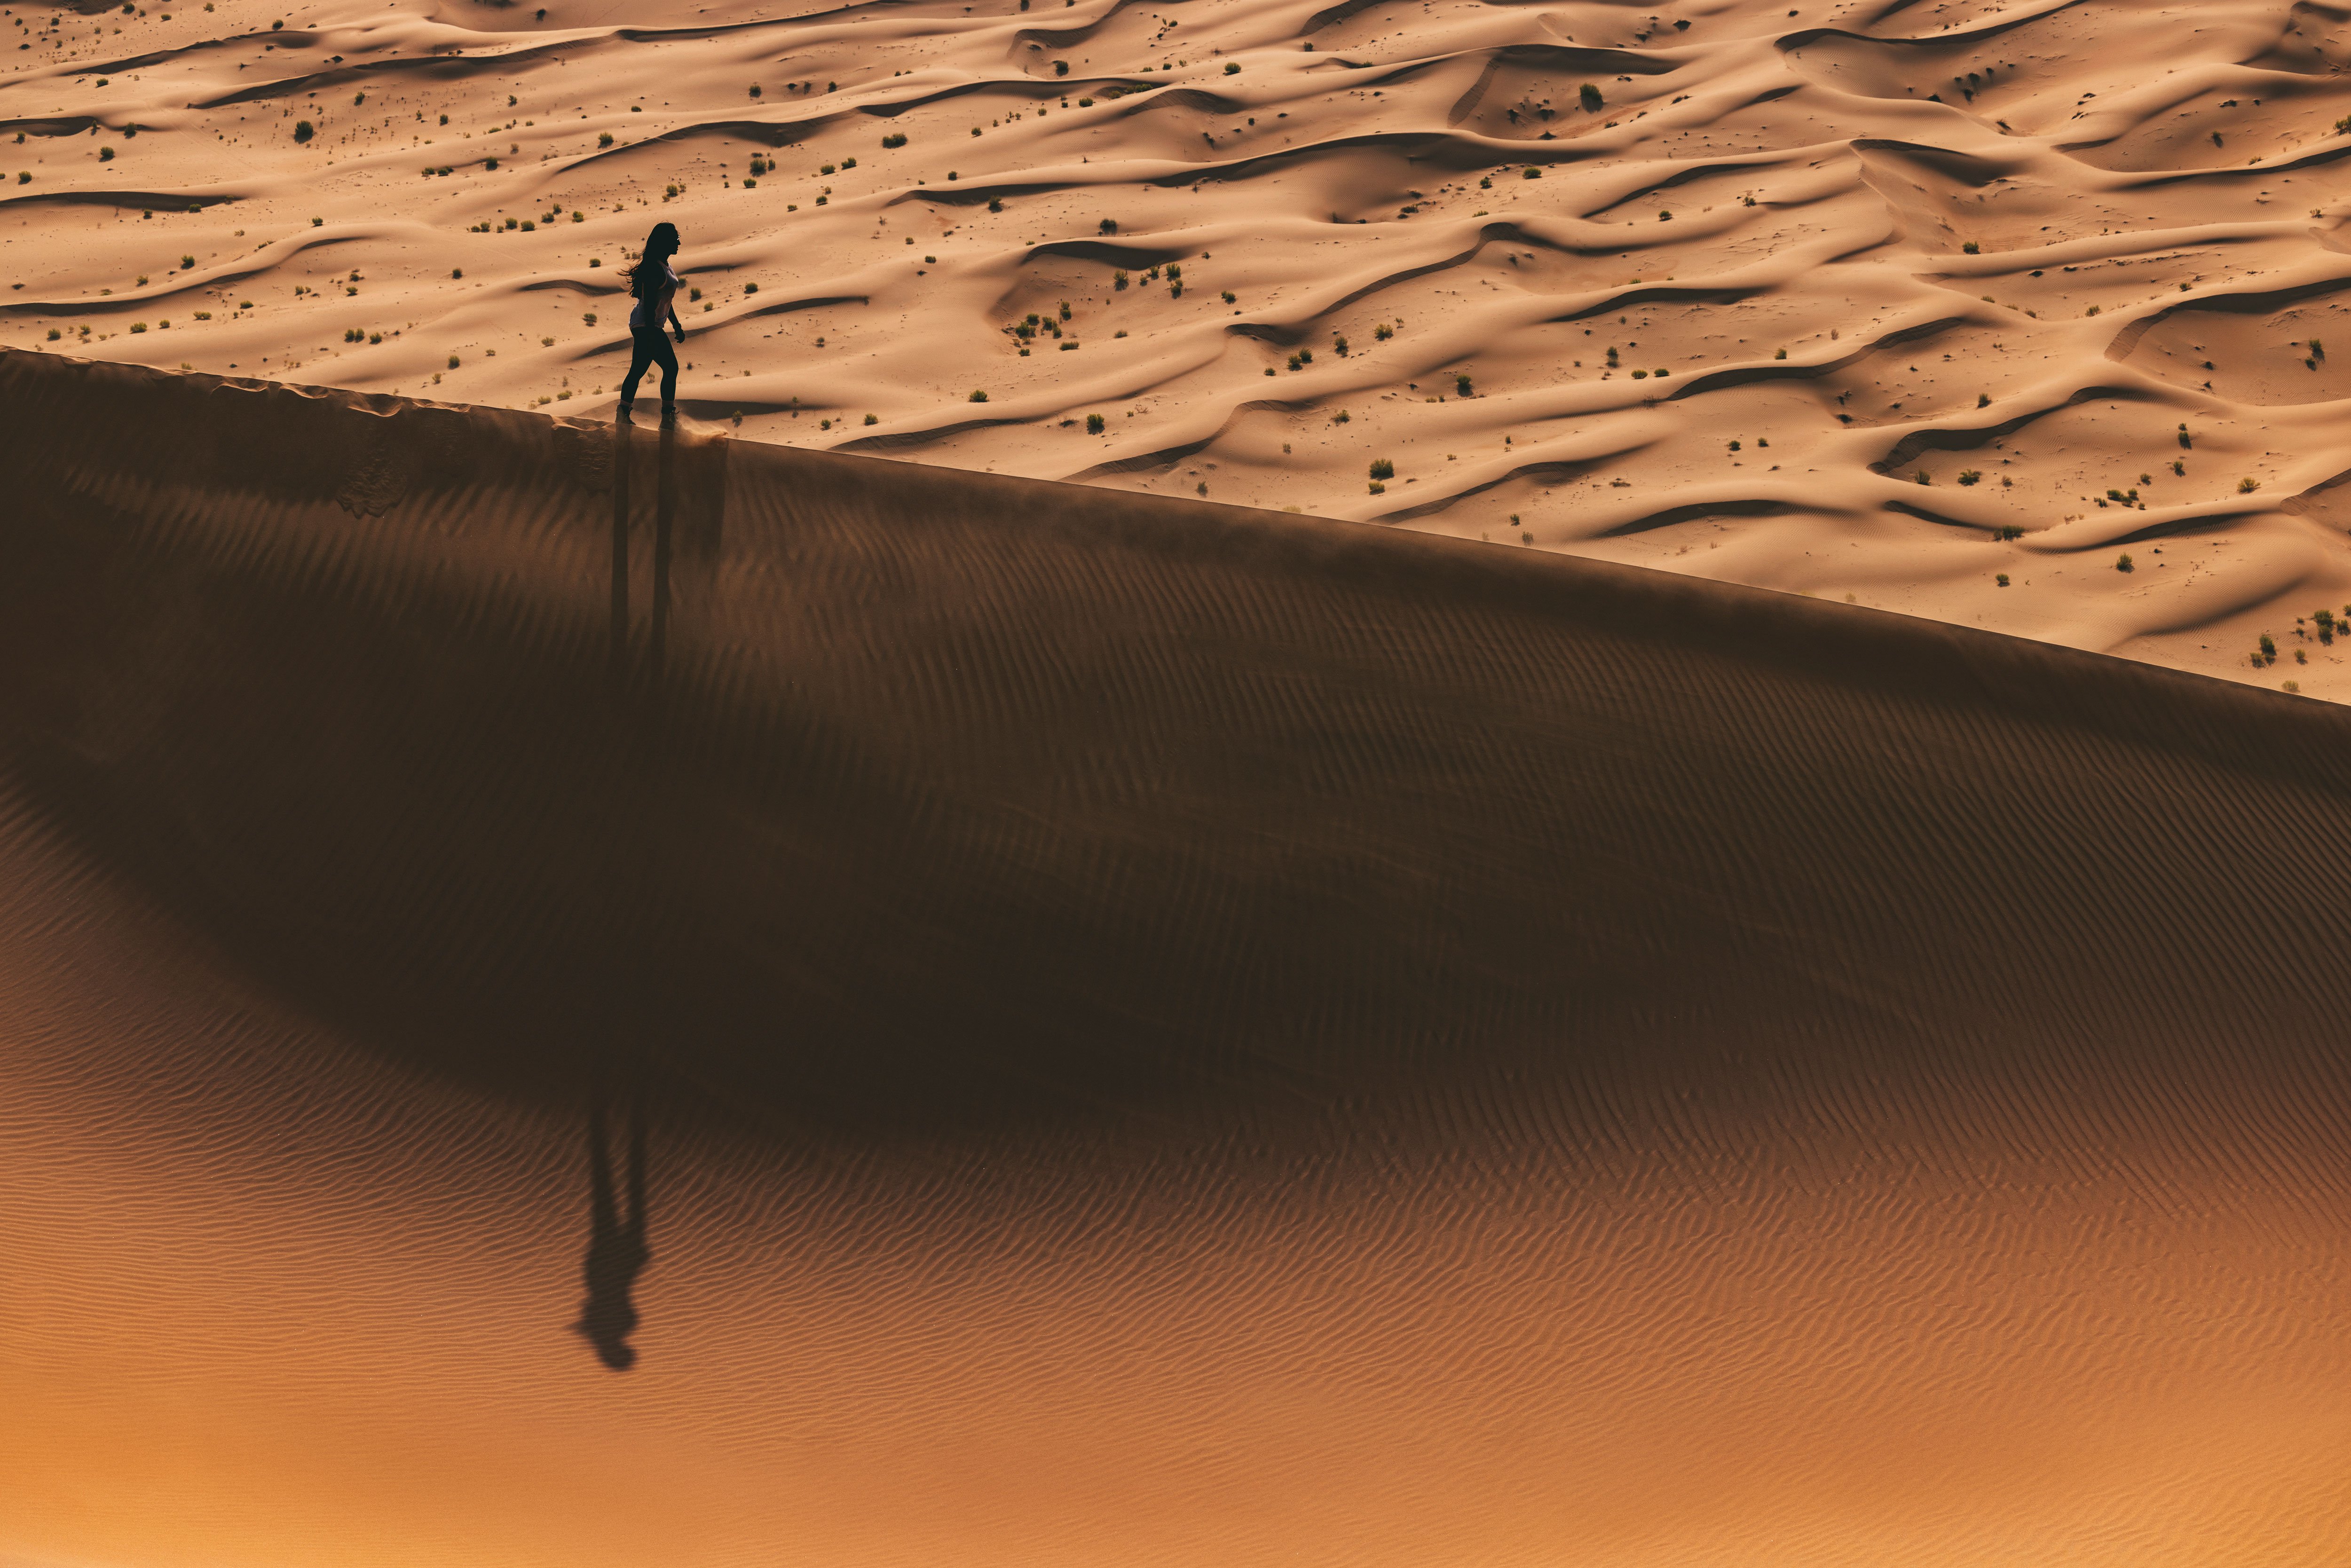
(14, 0), (2351, 698)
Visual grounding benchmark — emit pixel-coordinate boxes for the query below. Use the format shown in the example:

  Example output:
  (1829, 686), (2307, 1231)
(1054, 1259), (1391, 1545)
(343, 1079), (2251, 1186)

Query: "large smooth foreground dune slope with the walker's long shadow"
(0, 353), (2351, 1568)
